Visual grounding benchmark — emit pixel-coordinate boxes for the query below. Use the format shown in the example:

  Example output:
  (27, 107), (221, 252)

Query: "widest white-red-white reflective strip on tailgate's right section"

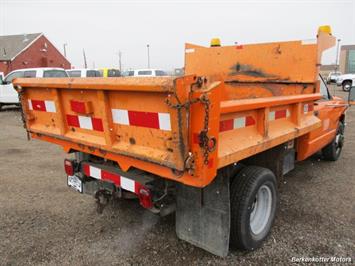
(112, 109), (171, 131)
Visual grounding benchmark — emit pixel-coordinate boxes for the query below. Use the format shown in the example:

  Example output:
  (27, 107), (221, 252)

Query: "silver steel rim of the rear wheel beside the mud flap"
(250, 185), (273, 235)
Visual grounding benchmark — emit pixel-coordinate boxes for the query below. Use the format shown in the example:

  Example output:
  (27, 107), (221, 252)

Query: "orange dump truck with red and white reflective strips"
(14, 27), (347, 256)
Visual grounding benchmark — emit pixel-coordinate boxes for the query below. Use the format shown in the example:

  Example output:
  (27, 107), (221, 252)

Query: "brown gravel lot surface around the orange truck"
(0, 88), (355, 265)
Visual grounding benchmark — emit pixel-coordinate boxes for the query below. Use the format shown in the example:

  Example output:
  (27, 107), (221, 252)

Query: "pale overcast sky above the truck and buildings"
(0, 0), (355, 70)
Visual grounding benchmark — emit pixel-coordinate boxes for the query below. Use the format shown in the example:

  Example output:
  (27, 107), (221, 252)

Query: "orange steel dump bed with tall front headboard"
(15, 29), (334, 187)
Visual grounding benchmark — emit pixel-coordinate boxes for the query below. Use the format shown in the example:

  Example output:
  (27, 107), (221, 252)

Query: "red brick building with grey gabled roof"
(0, 33), (71, 75)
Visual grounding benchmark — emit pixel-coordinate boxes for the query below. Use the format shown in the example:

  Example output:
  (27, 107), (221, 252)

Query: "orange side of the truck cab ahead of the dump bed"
(297, 76), (347, 160)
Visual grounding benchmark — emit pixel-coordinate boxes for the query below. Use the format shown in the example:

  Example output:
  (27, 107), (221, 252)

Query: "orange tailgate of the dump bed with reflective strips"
(16, 78), (191, 170)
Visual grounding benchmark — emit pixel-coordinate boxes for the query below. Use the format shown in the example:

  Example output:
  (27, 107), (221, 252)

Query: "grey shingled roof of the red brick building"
(0, 33), (43, 61)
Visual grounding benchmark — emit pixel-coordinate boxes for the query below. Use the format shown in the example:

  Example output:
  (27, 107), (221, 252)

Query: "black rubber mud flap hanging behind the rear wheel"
(176, 175), (230, 257)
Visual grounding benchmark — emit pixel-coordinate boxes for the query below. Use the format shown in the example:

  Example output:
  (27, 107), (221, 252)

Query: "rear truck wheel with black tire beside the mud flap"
(230, 166), (278, 250)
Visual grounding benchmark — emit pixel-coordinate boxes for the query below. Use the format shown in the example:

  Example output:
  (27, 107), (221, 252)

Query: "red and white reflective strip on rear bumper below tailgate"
(83, 164), (143, 194)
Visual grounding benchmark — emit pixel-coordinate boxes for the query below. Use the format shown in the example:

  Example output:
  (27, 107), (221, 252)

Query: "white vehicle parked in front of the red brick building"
(0, 67), (68, 109)
